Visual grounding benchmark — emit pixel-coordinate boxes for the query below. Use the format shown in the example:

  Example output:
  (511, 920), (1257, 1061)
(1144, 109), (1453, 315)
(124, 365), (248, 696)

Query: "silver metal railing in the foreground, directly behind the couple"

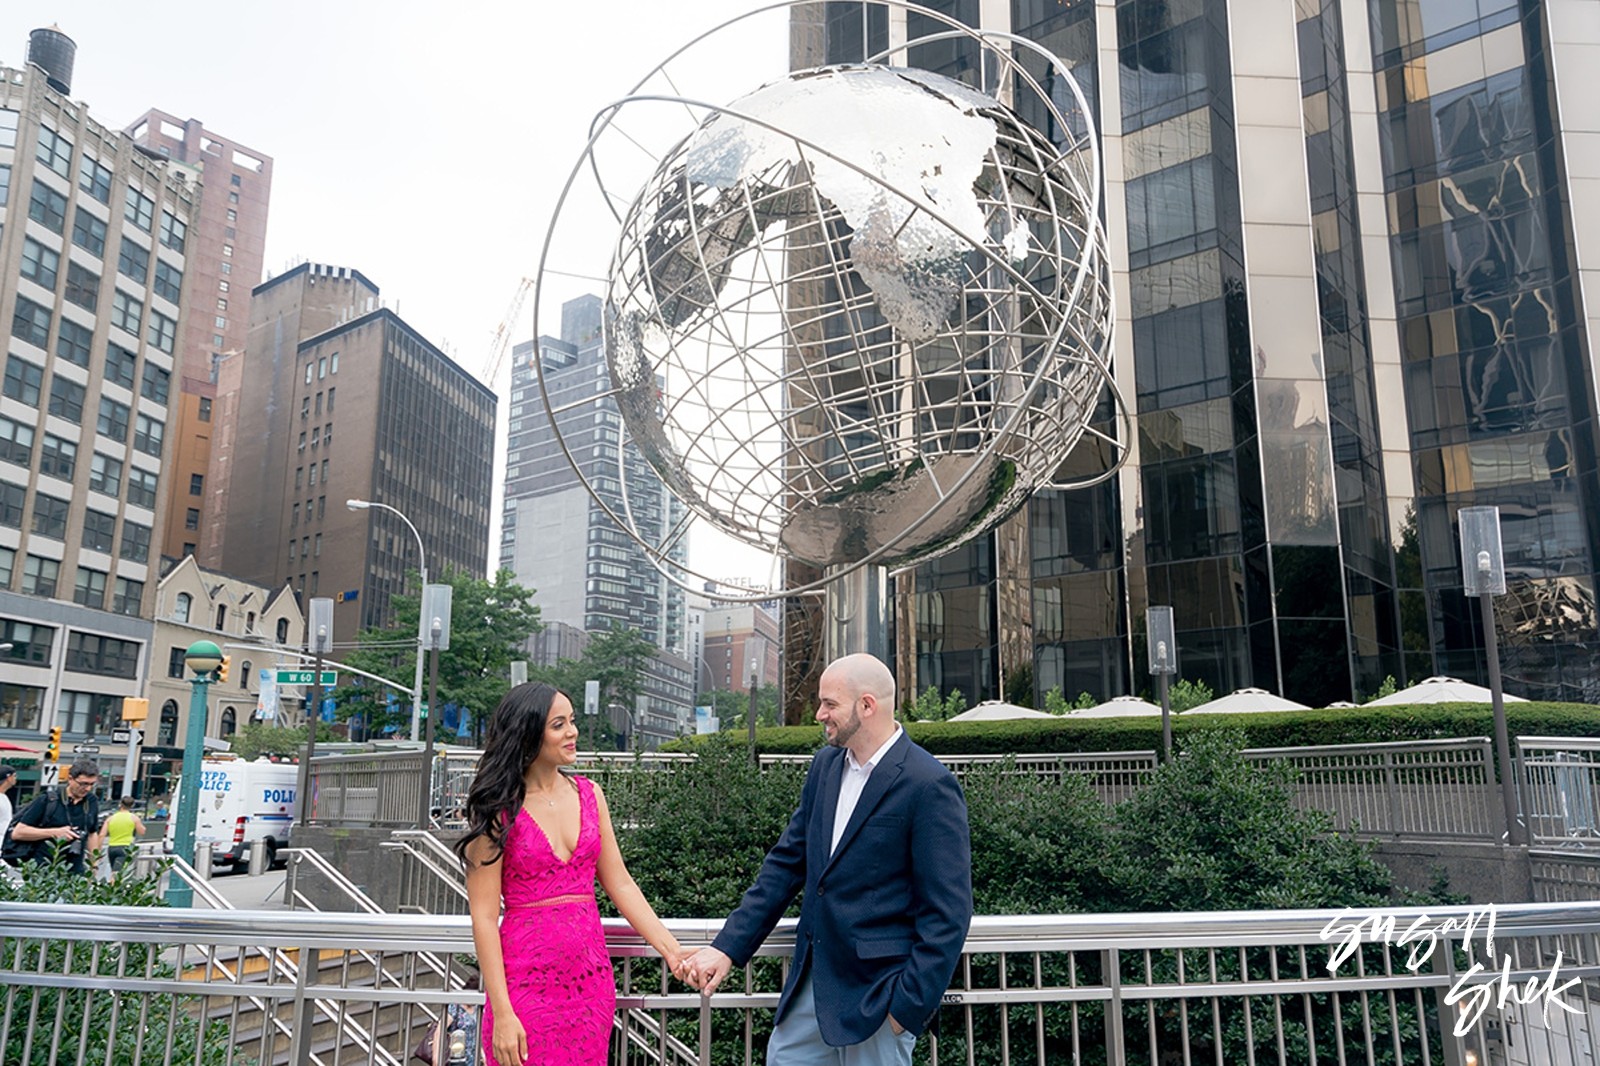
(0, 903), (1600, 1066)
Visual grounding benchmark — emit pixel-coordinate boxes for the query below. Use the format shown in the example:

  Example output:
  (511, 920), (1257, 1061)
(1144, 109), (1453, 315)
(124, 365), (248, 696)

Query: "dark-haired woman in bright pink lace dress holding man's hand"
(456, 683), (683, 1066)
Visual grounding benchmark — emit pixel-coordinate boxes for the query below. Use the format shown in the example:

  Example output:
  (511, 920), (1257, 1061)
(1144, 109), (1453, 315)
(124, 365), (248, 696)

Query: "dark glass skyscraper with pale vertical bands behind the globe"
(792, 0), (1600, 704)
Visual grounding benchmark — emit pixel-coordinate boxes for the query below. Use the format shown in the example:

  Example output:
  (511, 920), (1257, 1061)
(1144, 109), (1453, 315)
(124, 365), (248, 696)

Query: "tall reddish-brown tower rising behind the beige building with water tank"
(126, 110), (272, 565)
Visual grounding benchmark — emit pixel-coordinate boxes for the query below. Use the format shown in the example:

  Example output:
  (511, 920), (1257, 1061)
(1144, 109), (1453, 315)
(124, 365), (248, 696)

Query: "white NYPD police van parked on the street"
(166, 755), (299, 866)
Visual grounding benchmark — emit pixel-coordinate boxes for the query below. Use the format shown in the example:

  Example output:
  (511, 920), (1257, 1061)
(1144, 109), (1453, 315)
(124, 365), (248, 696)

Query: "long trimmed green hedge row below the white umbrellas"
(697, 703), (1600, 755)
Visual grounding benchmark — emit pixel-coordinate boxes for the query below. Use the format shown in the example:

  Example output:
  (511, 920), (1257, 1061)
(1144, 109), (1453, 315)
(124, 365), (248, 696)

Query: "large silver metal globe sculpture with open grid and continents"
(541, 10), (1126, 591)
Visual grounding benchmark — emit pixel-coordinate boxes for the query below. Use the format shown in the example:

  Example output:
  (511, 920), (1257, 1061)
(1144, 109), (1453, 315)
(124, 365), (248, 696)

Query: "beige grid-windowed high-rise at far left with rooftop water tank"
(0, 30), (195, 794)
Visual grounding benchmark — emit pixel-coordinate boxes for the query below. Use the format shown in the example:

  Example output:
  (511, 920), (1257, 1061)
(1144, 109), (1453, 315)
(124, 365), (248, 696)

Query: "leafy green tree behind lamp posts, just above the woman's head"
(333, 570), (541, 733)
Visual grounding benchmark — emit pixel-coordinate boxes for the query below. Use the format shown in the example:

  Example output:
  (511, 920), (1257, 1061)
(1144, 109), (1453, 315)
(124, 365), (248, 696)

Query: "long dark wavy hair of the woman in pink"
(456, 682), (558, 863)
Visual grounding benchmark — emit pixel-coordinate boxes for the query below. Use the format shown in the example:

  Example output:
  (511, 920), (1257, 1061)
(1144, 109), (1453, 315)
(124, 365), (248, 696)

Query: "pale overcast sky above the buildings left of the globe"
(0, 0), (787, 578)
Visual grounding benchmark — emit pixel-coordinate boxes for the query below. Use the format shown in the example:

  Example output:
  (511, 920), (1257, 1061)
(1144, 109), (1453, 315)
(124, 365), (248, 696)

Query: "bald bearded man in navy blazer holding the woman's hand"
(688, 655), (973, 1066)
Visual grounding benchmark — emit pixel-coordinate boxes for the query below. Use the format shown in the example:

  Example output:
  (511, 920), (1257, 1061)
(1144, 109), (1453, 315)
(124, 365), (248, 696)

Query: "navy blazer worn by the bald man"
(714, 731), (973, 1047)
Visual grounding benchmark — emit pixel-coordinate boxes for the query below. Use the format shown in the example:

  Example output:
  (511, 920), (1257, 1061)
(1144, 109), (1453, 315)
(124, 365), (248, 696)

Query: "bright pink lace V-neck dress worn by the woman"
(483, 775), (616, 1066)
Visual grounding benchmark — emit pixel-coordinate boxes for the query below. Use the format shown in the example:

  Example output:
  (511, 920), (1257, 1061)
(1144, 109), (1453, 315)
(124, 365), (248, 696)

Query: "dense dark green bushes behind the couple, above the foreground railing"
(606, 723), (1427, 917)
